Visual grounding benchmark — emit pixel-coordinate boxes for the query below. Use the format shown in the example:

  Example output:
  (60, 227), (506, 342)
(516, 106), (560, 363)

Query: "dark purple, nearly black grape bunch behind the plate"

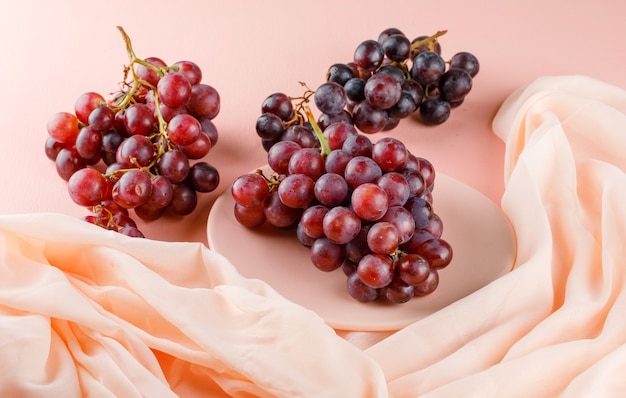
(316, 28), (479, 134)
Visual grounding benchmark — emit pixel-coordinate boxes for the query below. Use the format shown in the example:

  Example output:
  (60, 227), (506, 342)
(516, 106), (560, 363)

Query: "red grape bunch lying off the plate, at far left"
(45, 27), (220, 237)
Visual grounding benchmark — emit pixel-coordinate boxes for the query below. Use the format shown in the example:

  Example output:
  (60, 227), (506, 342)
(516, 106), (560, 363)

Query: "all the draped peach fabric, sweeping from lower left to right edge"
(0, 76), (626, 398)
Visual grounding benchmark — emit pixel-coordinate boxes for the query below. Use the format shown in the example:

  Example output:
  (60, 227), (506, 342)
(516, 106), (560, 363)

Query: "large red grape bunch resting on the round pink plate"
(231, 85), (452, 303)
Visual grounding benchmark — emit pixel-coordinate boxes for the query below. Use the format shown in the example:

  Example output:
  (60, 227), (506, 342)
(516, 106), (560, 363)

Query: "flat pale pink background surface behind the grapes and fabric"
(0, 0), (626, 243)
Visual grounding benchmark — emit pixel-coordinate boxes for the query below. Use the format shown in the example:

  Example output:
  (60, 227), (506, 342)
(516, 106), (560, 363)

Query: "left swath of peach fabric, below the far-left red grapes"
(0, 214), (386, 397)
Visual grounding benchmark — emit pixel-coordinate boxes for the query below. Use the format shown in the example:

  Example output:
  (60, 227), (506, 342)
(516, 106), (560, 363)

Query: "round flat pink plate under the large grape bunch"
(208, 168), (516, 331)
